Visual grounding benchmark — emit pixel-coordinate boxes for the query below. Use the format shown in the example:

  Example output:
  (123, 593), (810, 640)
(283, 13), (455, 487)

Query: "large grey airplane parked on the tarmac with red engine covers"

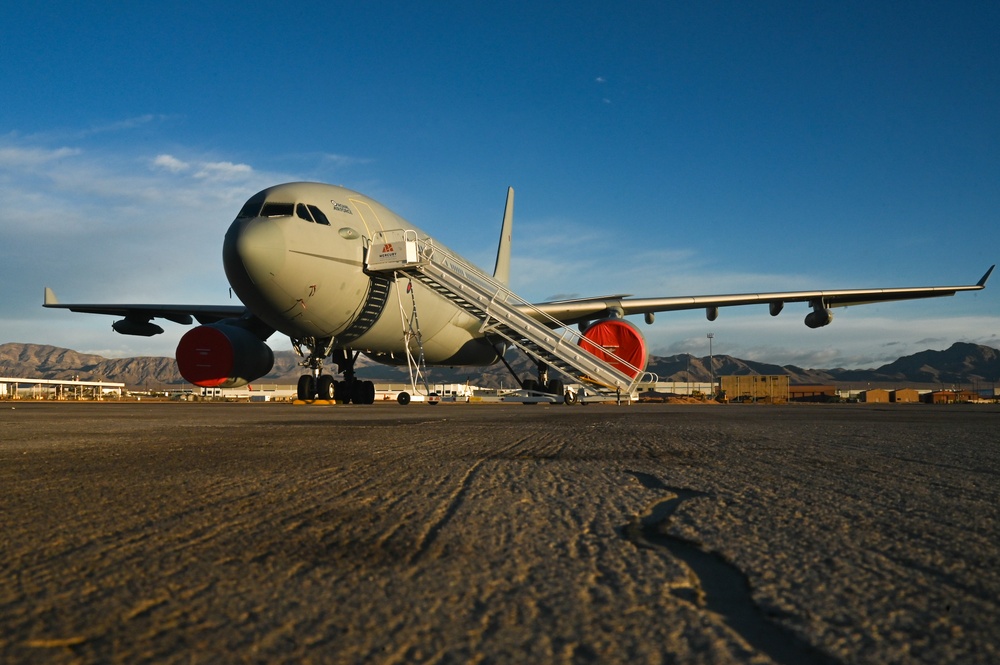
(43, 182), (995, 404)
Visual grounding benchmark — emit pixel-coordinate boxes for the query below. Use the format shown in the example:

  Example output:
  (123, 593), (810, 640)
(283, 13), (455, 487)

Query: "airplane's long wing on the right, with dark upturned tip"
(532, 266), (995, 324)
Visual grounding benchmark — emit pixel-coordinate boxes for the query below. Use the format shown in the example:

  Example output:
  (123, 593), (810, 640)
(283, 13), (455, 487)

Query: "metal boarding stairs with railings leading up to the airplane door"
(366, 229), (652, 398)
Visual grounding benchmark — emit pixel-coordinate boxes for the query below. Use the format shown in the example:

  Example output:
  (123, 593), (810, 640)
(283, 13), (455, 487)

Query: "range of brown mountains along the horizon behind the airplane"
(0, 342), (1000, 388)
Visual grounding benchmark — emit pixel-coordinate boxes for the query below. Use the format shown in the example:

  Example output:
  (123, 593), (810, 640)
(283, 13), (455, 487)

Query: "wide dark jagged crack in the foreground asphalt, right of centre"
(621, 471), (838, 664)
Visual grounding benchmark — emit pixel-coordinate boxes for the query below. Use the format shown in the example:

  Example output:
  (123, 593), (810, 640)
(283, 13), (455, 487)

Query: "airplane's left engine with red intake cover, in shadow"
(176, 323), (274, 388)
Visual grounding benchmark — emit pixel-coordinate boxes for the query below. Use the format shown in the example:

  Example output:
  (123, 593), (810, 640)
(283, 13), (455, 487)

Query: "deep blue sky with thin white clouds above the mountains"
(0, 2), (1000, 368)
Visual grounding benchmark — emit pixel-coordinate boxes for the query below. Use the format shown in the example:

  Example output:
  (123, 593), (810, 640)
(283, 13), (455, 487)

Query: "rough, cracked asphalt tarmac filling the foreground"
(0, 402), (1000, 663)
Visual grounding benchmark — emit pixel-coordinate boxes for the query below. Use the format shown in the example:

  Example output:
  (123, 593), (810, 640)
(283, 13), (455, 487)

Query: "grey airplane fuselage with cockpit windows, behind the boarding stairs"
(223, 183), (497, 365)
